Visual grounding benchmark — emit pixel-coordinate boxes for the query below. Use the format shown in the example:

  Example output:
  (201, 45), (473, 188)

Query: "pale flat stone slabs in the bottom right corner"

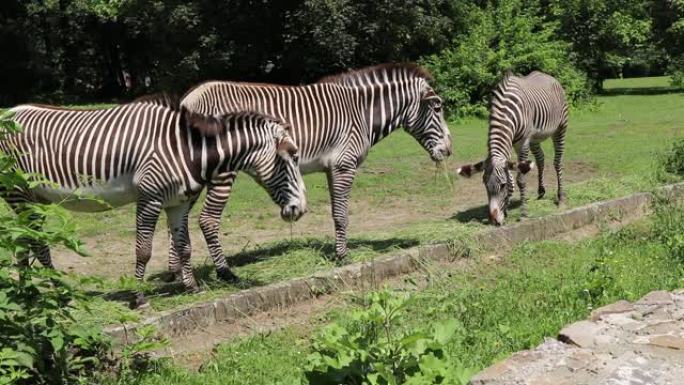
(471, 290), (684, 385)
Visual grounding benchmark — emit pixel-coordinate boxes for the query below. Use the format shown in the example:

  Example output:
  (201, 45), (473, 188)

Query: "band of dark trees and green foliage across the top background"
(0, 0), (684, 112)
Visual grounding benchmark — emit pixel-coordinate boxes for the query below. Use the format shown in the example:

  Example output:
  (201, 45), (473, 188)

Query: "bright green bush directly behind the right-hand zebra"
(422, 0), (590, 116)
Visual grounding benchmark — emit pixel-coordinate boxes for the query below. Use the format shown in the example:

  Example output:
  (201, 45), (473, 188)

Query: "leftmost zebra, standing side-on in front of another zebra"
(0, 102), (306, 304)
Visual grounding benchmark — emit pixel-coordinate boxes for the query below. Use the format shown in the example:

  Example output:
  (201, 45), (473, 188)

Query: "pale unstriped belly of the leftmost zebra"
(33, 173), (138, 212)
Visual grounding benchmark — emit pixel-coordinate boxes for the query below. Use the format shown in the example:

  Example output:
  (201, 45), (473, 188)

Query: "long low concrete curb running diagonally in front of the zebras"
(105, 183), (684, 345)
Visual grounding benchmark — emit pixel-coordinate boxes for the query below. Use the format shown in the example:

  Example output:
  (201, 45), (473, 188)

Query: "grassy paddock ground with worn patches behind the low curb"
(1, 78), (684, 323)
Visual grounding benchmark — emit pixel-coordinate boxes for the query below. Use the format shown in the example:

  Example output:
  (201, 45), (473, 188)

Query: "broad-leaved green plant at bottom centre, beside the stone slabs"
(306, 289), (473, 385)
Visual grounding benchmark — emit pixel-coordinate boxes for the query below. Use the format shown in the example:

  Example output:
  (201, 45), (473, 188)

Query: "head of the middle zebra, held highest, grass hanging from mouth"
(404, 84), (452, 162)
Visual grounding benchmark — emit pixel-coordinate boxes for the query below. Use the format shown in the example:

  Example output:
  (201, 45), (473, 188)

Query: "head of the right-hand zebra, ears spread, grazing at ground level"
(456, 157), (534, 226)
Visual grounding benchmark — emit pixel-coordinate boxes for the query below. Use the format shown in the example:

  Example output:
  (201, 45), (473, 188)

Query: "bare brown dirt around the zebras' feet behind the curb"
(53, 161), (596, 278)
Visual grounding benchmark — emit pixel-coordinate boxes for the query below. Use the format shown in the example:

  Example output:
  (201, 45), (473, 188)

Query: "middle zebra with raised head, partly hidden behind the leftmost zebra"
(179, 64), (451, 279)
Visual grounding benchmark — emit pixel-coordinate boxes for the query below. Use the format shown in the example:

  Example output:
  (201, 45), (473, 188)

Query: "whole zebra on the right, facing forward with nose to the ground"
(457, 71), (568, 225)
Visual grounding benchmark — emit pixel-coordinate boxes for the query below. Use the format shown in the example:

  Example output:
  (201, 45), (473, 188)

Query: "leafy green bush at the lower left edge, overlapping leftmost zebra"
(0, 110), (109, 385)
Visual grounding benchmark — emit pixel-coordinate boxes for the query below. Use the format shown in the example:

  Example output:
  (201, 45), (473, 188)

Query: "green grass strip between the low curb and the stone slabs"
(99, 213), (684, 385)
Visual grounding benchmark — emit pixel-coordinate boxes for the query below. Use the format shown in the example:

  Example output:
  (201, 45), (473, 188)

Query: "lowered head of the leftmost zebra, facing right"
(248, 118), (307, 222)
